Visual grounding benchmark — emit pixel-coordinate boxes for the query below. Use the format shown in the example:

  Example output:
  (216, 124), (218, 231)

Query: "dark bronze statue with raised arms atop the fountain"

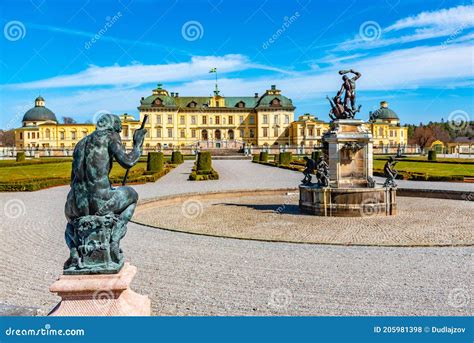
(326, 69), (362, 120)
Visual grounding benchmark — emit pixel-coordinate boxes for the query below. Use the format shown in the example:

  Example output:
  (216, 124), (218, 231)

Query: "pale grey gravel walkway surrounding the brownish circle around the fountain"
(0, 161), (474, 315)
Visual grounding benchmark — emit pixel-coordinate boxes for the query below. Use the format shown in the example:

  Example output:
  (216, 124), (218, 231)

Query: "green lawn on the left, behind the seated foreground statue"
(0, 161), (146, 183)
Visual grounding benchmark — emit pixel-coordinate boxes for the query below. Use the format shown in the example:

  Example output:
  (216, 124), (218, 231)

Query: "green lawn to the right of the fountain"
(374, 160), (474, 176)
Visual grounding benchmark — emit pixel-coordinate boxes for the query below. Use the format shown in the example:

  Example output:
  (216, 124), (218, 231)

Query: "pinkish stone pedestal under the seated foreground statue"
(49, 263), (151, 316)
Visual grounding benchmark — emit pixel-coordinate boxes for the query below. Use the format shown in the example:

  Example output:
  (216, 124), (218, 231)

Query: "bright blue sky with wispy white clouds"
(0, 0), (474, 128)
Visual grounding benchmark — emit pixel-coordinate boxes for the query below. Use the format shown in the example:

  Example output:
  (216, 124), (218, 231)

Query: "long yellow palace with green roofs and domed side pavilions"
(15, 84), (408, 156)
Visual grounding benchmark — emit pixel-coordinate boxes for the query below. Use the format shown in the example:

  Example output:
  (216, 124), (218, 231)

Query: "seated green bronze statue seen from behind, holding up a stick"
(64, 114), (147, 274)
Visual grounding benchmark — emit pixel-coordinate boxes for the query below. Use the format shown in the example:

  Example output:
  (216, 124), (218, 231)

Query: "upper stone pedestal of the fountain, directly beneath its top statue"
(323, 119), (373, 188)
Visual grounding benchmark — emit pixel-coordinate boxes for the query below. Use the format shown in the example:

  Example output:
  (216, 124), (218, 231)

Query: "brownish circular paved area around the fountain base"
(134, 192), (474, 246)
